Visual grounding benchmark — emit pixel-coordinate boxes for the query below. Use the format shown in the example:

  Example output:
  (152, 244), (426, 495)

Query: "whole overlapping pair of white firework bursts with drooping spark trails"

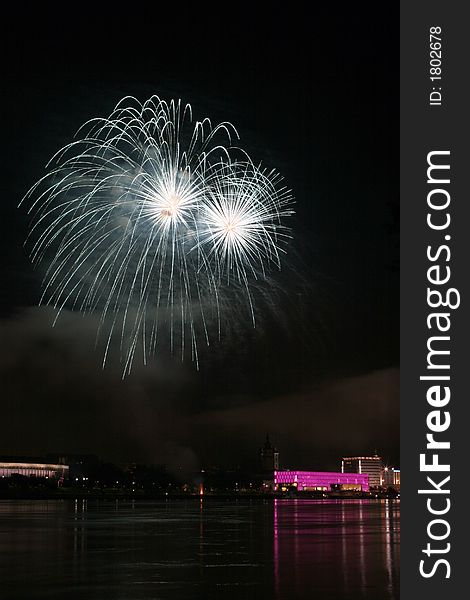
(23, 96), (293, 375)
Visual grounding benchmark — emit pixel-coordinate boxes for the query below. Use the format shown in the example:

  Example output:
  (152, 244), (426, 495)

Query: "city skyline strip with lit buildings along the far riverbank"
(0, 433), (400, 497)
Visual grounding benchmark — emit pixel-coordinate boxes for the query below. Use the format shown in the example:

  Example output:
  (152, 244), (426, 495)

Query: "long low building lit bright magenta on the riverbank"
(274, 471), (369, 492)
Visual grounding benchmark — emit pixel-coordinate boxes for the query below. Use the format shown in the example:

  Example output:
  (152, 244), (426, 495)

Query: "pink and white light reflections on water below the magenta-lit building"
(273, 499), (400, 600)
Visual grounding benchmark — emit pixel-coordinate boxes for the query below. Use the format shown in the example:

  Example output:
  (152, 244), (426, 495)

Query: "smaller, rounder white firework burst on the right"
(200, 160), (293, 290)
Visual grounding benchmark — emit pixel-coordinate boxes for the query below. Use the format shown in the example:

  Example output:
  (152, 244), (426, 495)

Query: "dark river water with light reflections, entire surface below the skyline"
(0, 498), (400, 600)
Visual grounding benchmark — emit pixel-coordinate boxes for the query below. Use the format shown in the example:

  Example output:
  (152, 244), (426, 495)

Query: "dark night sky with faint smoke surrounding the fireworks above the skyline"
(0, 2), (399, 469)
